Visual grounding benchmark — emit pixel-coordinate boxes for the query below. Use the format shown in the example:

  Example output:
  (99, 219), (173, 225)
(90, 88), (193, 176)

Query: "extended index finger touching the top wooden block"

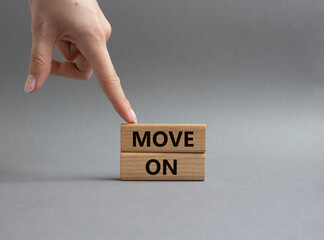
(81, 39), (137, 123)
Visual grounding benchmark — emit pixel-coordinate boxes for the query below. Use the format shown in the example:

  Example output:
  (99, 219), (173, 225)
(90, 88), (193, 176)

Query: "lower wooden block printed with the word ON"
(120, 153), (205, 181)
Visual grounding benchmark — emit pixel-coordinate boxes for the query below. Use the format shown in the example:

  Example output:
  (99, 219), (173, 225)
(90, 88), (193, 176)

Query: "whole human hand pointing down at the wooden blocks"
(25, 0), (137, 123)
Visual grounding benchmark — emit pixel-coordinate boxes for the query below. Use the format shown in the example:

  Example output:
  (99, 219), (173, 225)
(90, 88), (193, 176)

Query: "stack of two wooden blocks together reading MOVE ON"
(120, 124), (206, 181)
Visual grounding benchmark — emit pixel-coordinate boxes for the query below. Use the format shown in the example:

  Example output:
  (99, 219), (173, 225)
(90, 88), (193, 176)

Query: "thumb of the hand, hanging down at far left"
(25, 33), (55, 92)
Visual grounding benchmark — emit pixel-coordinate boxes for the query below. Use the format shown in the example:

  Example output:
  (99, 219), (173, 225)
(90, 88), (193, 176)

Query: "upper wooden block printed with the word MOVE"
(121, 124), (206, 153)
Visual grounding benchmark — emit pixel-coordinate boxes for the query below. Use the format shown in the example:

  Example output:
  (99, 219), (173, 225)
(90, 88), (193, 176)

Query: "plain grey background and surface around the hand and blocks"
(0, 0), (324, 239)
